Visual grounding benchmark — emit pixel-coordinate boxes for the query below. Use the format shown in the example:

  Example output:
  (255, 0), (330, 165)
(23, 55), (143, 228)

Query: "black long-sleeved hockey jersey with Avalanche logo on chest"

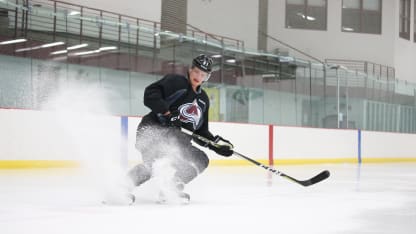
(142, 74), (214, 140)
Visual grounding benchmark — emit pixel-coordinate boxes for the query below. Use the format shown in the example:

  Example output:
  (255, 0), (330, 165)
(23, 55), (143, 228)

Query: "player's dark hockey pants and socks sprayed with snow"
(129, 122), (209, 186)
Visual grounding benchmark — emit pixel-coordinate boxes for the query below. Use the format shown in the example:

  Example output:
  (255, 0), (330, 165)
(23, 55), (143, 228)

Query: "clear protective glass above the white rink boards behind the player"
(0, 55), (416, 133)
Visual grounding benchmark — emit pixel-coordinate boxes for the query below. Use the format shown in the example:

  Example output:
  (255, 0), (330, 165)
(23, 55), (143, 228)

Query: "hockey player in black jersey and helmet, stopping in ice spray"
(128, 54), (233, 202)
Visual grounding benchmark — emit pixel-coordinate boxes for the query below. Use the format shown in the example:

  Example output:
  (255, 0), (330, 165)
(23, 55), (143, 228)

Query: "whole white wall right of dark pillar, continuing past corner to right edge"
(268, 0), (416, 82)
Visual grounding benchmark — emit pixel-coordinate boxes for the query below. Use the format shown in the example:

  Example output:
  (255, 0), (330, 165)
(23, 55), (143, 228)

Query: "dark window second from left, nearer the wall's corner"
(342, 0), (381, 34)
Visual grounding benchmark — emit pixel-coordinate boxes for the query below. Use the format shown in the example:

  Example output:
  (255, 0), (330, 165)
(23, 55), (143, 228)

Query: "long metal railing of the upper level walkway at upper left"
(0, 0), (244, 49)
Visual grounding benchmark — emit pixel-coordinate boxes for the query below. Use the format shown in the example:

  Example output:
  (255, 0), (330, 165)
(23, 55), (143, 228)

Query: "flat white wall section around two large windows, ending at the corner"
(268, 0), (394, 66)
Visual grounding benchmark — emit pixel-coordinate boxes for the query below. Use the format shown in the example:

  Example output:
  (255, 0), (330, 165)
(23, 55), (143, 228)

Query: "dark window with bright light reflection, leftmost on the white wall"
(286, 0), (327, 30)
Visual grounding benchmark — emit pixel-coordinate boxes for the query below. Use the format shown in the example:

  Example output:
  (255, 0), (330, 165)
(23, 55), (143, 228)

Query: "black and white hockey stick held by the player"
(182, 128), (330, 187)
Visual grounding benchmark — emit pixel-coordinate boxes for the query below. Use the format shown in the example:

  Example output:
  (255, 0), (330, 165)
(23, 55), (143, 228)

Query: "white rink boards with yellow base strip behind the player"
(0, 109), (416, 169)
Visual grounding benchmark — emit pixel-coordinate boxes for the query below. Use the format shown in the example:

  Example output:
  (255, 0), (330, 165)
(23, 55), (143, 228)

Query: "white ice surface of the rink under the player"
(0, 164), (416, 234)
